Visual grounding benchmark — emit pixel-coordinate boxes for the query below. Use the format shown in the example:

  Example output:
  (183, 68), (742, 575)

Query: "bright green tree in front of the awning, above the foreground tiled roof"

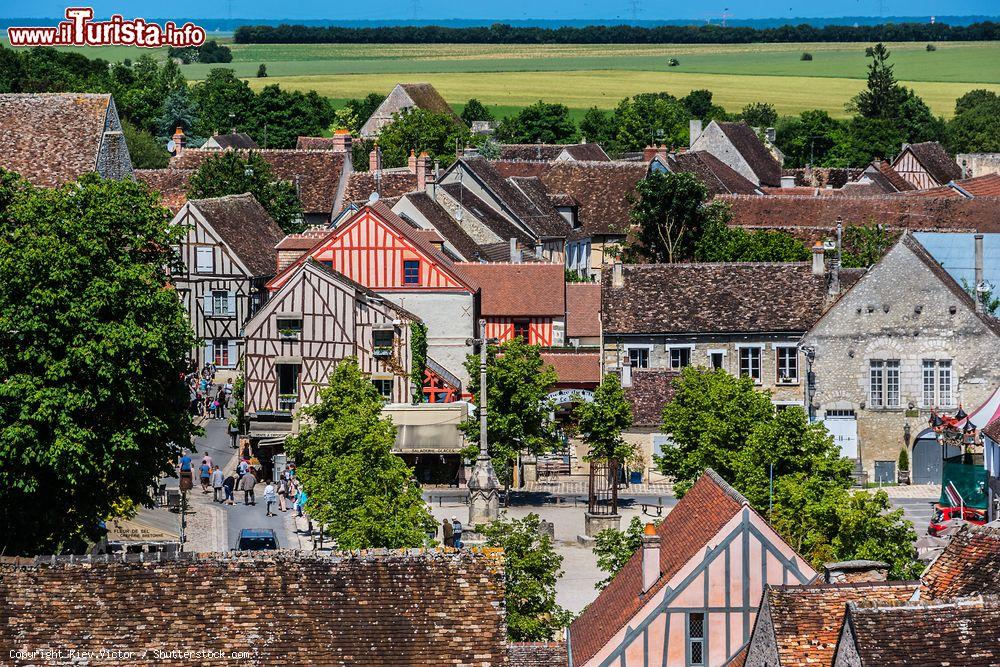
(286, 357), (435, 549)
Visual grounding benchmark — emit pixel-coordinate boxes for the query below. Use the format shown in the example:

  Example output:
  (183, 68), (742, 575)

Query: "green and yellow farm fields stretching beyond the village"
(9, 42), (1000, 117)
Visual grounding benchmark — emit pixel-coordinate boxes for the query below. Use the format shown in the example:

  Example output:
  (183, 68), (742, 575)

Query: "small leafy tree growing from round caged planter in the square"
(574, 374), (634, 463)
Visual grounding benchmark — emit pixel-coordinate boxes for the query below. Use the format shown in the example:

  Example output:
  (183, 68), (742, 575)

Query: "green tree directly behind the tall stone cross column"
(460, 337), (557, 486)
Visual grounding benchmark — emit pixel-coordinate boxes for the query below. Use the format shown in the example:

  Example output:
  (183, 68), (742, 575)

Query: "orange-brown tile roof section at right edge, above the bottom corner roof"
(920, 526), (1000, 600)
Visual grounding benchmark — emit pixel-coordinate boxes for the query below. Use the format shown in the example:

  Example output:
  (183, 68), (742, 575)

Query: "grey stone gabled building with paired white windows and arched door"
(801, 234), (1000, 483)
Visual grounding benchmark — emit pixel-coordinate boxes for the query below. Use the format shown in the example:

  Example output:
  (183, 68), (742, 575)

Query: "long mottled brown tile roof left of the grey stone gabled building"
(601, 262), (827, 334)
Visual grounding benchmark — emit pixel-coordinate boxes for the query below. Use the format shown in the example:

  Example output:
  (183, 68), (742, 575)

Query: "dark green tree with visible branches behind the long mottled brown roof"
(625, 172), (728, 263)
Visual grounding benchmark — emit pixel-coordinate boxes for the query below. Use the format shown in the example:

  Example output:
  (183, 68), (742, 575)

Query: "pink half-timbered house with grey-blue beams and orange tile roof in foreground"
(567, 470), (816, 667)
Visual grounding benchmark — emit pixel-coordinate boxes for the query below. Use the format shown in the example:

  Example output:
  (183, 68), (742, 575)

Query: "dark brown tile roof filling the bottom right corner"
(840, 596), (1000, 667)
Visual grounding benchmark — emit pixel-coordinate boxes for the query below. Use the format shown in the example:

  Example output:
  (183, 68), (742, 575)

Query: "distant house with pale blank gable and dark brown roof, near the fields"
(690, 120), (781, 187)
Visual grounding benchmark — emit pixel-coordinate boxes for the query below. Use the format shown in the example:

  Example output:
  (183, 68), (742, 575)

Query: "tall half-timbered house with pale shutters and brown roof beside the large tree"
(170, 194), (283, 372)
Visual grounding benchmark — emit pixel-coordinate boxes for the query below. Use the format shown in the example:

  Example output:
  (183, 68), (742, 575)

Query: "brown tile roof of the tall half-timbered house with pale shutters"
(190, 193), (284, 276)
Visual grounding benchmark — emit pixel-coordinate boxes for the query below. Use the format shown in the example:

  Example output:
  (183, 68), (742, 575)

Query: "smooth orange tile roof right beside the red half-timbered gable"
(455, 262), (566, 317)
